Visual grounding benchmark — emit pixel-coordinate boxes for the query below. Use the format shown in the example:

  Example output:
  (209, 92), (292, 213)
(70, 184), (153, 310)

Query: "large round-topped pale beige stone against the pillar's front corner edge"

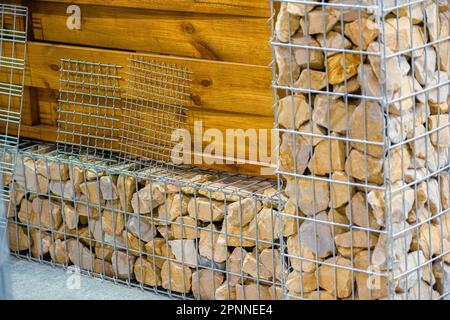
(349, 102), (384, 158)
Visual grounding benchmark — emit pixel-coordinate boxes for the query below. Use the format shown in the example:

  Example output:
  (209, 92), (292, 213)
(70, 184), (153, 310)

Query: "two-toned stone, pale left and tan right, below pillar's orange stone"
(312, 94), (355, 133)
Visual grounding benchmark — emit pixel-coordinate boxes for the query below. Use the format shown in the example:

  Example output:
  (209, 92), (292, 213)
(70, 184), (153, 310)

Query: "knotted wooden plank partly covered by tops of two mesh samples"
(21, 41), (273, 116)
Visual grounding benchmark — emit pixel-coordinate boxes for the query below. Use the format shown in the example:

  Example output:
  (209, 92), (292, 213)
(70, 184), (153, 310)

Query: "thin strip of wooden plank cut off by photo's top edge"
(34, 0), (270, 18)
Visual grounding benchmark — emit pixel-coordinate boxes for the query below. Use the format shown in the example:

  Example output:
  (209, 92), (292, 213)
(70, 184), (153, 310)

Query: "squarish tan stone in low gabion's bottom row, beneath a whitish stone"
(161, 260), (192, 293)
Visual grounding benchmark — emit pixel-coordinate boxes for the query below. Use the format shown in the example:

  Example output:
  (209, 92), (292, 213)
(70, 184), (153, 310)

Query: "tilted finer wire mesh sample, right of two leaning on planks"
(120, 56), (192, 167)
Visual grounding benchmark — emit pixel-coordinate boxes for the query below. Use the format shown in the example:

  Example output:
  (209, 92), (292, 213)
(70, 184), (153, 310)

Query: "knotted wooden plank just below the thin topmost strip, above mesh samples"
(30, 1), (271, 66)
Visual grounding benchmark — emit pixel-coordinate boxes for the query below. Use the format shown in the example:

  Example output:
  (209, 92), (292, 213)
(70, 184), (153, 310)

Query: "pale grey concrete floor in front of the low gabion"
(9, 257), (168, 300)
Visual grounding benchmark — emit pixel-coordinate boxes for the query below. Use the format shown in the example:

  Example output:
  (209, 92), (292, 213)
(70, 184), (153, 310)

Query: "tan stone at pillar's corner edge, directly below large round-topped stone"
(346, 149), (383, 185)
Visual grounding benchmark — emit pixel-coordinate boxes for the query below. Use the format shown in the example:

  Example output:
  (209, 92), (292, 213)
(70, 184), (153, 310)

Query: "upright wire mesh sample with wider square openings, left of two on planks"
(57, 59), (121, 159)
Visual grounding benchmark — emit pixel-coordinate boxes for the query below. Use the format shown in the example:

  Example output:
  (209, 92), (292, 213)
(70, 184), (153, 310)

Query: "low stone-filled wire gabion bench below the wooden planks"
(6, 148), (281, 300)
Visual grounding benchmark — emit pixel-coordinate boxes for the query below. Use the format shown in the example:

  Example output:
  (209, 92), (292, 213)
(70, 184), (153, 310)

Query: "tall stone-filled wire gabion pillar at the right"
(271, 0), (450, 299)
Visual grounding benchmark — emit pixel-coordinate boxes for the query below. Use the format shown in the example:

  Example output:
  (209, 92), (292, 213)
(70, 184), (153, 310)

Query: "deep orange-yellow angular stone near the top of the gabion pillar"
(327, 53), (361, 85)
